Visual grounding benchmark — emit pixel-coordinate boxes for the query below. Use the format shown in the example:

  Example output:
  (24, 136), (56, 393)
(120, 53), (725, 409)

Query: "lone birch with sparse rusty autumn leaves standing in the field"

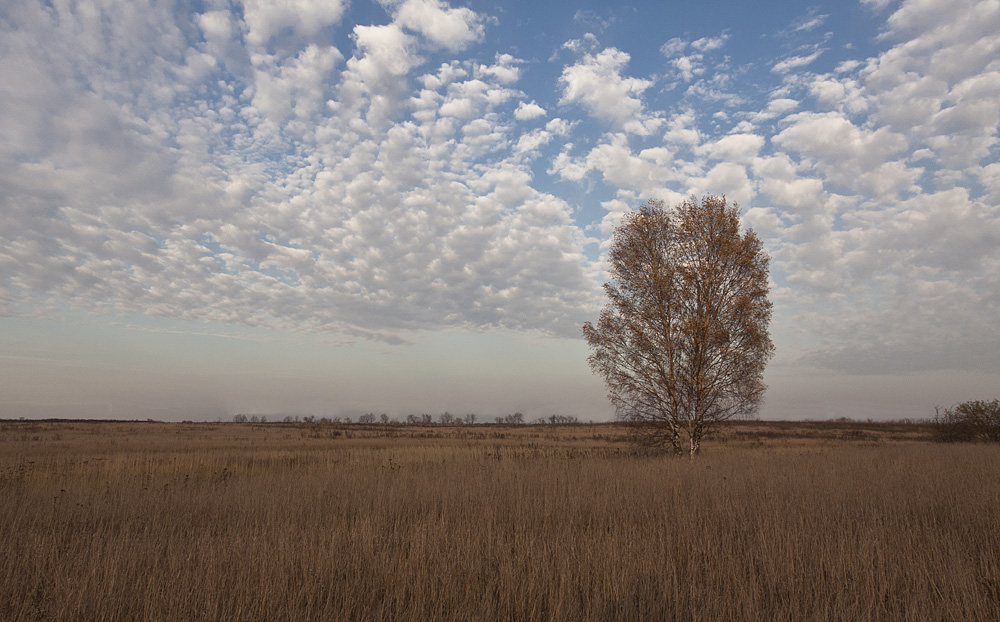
(583, 196), (774, 458)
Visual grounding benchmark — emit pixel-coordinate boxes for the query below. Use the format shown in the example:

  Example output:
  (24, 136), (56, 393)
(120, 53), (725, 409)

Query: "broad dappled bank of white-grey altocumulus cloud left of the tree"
(0, 0), (595, 341)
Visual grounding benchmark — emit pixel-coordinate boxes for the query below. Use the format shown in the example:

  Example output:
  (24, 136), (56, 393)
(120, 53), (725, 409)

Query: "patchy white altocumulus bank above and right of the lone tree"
(551, 0), (1000, 373)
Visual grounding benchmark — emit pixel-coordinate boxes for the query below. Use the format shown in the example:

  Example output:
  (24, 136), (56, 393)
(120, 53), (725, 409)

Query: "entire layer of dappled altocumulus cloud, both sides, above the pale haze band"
(0, 0), (1000, 380)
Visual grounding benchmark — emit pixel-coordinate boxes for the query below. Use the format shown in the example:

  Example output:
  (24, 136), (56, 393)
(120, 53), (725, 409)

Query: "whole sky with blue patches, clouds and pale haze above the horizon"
(0, 0), (1000, 420)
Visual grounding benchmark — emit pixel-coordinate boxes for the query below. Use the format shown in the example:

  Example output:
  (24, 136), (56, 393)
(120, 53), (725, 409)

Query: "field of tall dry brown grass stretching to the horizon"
(0, 421), (1000, 620)
